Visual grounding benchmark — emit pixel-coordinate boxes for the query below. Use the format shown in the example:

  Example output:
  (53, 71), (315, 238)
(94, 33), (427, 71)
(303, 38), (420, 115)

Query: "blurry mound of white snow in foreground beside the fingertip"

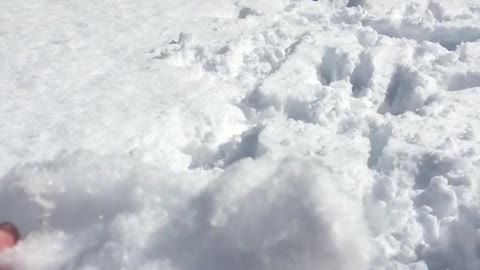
(1, 152), (369, 269)
